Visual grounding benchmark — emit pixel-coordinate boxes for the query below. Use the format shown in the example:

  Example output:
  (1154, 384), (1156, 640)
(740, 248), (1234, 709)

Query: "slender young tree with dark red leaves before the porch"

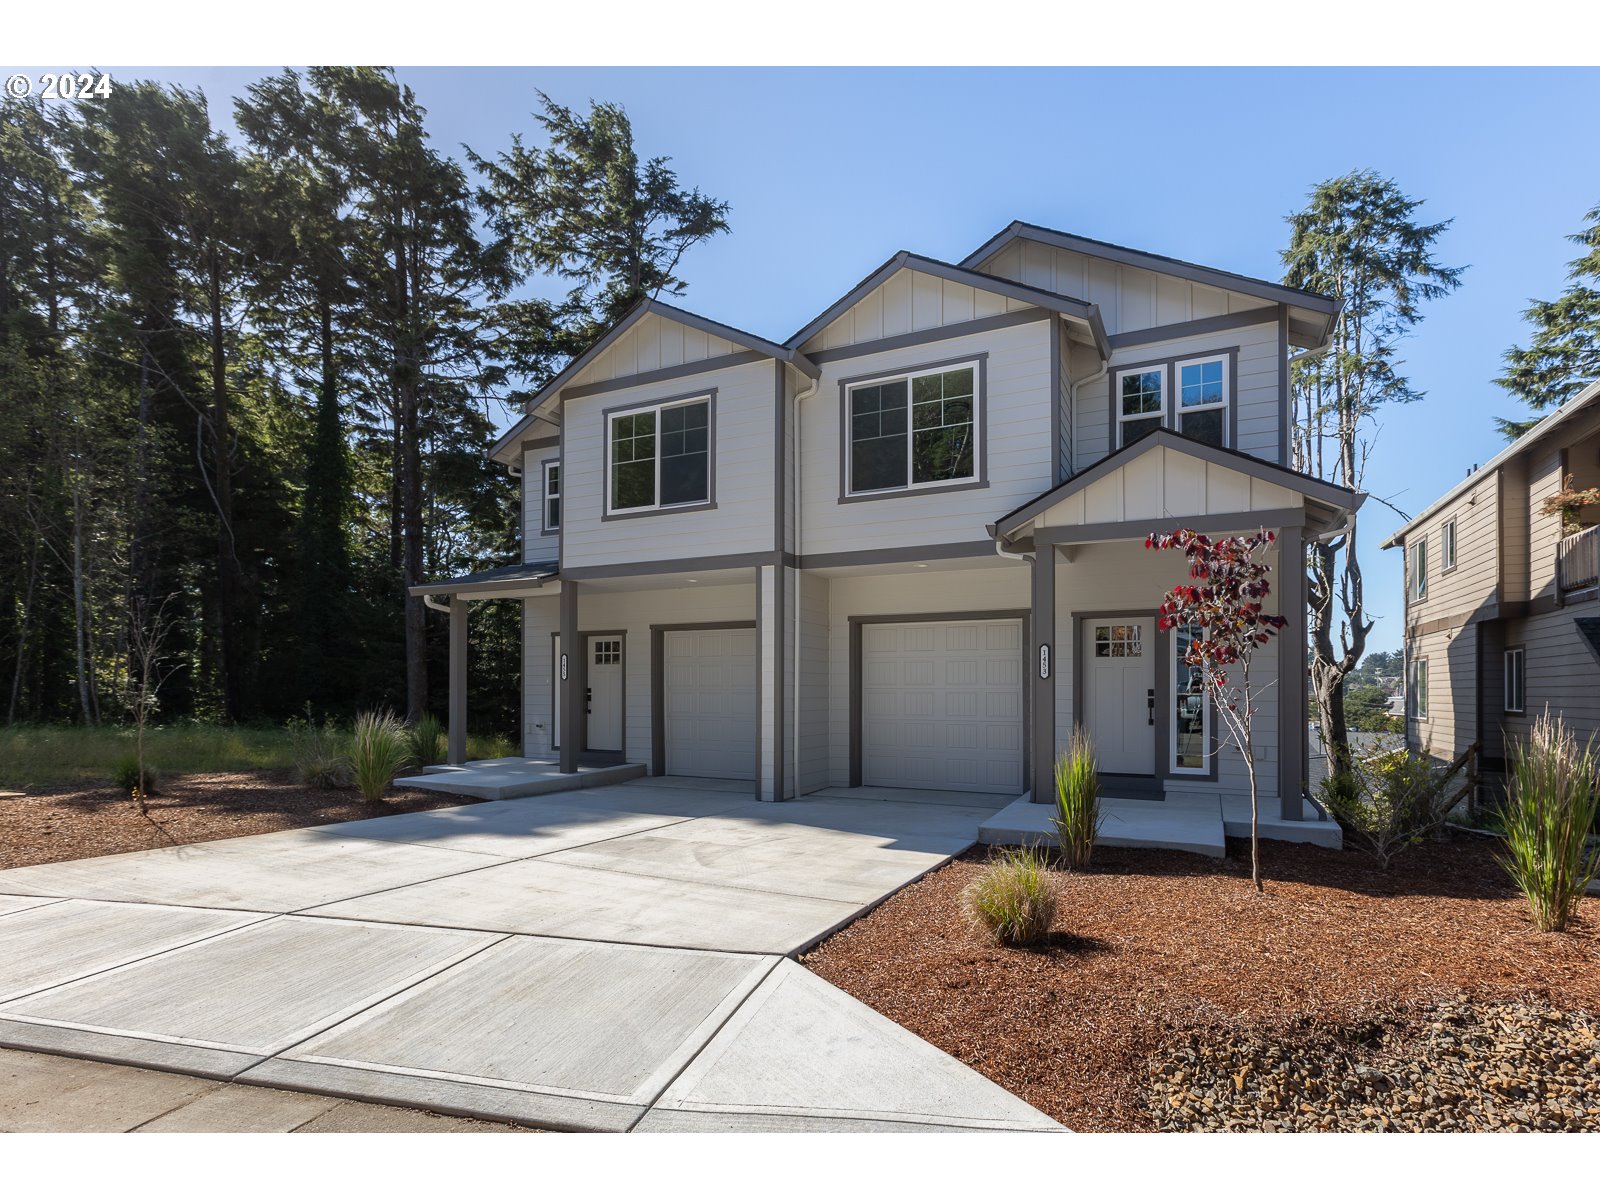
(1144, 530), (1296, 891)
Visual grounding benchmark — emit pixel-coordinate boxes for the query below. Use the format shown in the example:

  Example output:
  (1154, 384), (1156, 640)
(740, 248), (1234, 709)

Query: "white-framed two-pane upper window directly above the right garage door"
(846, 363), (979, 494)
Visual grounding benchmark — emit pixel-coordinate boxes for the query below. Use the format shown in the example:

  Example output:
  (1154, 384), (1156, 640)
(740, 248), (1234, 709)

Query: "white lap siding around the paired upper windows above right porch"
(1074, 320), (1285, 470)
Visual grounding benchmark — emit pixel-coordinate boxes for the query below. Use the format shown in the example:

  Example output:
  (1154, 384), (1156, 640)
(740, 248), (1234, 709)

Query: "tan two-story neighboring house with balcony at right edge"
(1384, 382), (1600, 776)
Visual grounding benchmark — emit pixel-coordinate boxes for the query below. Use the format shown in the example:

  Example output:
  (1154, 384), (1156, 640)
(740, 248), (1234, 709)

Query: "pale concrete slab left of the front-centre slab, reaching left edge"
(0, 917), (499, 1078)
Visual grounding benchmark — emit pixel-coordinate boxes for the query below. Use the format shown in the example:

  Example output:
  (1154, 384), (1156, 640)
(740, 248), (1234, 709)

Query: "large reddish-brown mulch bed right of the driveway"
(802, 834), (1600, 1131)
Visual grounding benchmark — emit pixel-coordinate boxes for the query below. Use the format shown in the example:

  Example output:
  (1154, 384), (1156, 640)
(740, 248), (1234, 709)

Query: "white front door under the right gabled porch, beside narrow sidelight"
(1082, 616), (1157, 774)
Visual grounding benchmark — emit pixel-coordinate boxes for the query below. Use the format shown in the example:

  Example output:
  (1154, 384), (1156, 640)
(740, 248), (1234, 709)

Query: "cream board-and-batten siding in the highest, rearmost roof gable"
(978, 238), (1277, 334)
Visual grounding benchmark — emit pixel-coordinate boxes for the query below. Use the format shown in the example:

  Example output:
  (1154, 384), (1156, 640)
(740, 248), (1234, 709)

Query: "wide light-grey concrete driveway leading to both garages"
(0, 779), (1059, 1131)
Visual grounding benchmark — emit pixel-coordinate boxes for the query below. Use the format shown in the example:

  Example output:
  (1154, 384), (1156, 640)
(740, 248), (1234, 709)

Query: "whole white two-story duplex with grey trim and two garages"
(414, 224), (1360, 821)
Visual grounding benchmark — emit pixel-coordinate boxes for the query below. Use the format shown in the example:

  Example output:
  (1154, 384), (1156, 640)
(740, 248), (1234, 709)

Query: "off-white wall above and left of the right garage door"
(802, 558), (1032, 787)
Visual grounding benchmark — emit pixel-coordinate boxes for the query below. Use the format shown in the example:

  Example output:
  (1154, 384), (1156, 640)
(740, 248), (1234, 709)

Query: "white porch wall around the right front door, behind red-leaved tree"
(1056, 542), (1298, 809)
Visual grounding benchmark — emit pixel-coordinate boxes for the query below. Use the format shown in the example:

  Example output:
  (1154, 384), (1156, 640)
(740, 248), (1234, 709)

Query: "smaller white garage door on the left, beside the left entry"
(662, 629), (755, 779)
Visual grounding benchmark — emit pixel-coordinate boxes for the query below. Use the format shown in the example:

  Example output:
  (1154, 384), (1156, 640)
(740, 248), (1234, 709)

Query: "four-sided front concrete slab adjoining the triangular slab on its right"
(243, 938), (776, 1131)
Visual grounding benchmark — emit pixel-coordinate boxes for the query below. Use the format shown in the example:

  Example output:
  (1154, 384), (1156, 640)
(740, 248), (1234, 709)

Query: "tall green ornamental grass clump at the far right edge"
(1499, 710), (1600, 933)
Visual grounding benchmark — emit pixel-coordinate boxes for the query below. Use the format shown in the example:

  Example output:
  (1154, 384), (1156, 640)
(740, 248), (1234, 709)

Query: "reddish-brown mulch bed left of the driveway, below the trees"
(0, 770), (472, 869)
